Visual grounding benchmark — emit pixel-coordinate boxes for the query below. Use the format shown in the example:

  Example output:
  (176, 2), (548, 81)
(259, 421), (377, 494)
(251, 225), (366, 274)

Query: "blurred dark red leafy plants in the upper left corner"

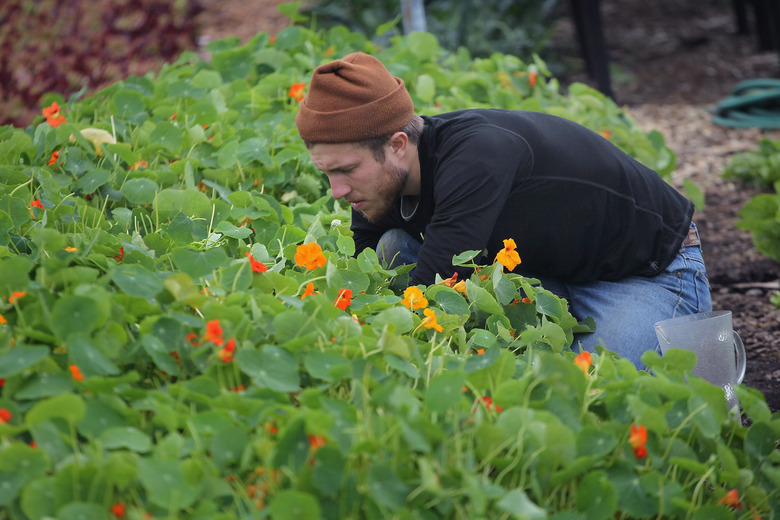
(0, 0), (203, 126)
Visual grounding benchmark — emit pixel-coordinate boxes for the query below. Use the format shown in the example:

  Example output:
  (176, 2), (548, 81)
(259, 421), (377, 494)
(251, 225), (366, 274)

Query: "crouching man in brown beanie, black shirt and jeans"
(296, 53), (712, 369)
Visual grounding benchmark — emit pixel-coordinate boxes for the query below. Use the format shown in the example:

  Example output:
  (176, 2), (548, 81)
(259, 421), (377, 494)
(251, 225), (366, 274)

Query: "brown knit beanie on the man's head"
(295, 52), (414, 143)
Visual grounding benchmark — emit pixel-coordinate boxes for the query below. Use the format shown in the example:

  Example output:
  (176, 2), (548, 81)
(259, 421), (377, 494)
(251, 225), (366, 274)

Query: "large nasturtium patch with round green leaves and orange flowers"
(0, 10), (780, 520)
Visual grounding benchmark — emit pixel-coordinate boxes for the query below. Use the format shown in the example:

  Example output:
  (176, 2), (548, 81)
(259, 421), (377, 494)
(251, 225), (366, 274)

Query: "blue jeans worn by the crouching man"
(377, 226), (712, 370)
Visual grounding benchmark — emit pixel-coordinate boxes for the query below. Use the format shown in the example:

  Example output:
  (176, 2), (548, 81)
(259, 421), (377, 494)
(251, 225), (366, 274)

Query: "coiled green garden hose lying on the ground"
(711, 78), (780, 129)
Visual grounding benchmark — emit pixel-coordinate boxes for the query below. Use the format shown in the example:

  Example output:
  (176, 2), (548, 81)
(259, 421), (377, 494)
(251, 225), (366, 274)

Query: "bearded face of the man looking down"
(309, 143), (409, 221)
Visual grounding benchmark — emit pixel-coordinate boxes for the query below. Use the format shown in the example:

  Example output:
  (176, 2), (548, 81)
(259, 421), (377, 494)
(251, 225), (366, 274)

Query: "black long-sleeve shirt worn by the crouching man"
(351, 109), (693, 284)
